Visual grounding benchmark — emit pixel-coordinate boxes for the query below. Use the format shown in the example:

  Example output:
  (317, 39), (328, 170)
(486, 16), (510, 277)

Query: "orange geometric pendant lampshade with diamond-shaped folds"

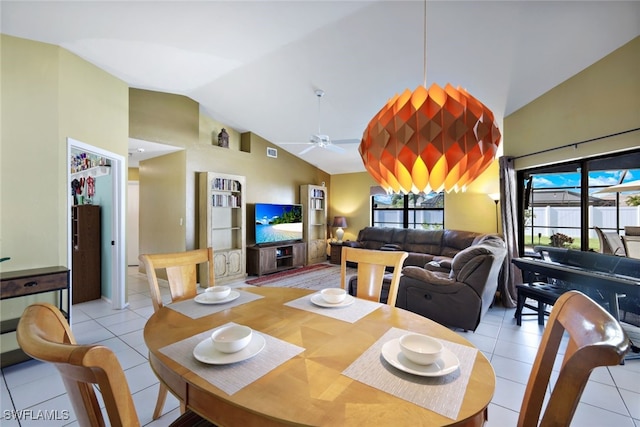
(358, 84), (501, 194)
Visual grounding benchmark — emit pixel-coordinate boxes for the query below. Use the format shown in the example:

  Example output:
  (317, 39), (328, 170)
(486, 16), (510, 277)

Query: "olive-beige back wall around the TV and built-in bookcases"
(130, 89), (330, 253)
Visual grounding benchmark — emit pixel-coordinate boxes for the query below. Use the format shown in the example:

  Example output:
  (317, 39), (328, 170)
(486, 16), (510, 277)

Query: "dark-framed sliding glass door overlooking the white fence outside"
(518, 151), (640, 252)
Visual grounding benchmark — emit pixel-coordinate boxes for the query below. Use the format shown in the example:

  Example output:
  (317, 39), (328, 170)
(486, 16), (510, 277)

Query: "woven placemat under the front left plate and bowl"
(160, 322), (304, 395)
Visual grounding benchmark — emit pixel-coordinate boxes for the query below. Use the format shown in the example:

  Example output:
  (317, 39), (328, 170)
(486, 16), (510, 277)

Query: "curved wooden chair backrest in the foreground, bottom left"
(17, 303), (140, 426)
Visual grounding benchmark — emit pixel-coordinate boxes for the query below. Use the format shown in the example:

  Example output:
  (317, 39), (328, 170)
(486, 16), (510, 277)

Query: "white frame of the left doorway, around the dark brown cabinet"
(65, 138), (127, 309)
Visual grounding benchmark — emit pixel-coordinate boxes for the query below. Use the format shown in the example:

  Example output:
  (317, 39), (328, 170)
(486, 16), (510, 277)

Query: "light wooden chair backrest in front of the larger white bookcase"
(138, 248), (214, 311)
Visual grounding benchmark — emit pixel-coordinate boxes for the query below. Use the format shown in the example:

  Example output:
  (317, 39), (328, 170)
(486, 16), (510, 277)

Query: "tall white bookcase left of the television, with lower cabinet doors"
(198, 172), (247, 284)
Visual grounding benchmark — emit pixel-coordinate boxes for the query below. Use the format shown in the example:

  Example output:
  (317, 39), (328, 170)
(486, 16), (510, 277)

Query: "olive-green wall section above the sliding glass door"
(504, 37), (640, 169)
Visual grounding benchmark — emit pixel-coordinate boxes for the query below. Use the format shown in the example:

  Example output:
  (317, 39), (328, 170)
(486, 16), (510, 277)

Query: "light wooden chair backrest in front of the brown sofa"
(340, 246), (409, 306)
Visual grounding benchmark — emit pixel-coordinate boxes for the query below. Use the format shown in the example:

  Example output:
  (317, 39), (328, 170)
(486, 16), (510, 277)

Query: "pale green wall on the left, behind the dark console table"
(0, 35), (129, 350)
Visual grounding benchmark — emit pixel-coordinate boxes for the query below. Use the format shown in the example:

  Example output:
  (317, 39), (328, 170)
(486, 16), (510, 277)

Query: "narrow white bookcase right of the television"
(300, 185), (328, 264)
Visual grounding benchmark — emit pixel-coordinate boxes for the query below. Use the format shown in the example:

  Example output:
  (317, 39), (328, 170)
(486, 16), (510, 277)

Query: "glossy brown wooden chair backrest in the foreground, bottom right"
(518, 291), (629, 427)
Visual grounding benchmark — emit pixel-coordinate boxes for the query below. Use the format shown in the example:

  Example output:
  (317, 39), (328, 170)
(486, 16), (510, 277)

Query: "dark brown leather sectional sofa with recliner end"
(344, 227), (507, 330)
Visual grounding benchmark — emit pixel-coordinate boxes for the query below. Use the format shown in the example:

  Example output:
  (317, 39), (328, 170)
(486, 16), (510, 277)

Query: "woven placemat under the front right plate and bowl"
(342, 328), (478, 420)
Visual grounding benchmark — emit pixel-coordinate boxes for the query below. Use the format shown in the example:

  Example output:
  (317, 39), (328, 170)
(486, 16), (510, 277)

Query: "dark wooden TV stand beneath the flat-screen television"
(247, 242), (306, 276)
